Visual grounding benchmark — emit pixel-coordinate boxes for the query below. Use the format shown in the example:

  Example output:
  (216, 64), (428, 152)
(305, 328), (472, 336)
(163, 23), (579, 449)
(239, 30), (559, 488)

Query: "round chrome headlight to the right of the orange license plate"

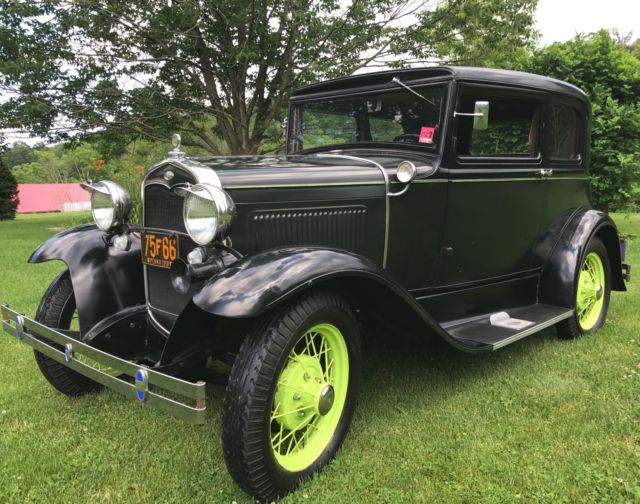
(183, 184), (235, 245)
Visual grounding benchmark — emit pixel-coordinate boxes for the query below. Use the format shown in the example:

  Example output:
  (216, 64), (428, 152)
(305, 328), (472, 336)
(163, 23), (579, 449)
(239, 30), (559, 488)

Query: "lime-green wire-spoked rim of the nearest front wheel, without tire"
(270, 323), (349, 471)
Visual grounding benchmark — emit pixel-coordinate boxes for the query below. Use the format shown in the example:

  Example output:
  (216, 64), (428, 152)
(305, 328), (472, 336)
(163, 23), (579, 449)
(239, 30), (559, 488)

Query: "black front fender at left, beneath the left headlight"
(29, 224), (145, 335)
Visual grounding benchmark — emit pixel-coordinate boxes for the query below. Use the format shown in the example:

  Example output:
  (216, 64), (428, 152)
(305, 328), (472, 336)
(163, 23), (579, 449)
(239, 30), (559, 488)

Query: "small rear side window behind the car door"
(546, 103), (582, 161)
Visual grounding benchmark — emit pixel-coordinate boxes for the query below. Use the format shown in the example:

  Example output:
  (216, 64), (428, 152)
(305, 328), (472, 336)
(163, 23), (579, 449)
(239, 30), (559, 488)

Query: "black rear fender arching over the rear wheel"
(540, 209), (627, 309)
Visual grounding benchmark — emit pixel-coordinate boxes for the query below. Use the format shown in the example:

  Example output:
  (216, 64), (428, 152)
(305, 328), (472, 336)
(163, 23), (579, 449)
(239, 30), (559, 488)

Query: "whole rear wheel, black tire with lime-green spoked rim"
(558, 237), (611, 339)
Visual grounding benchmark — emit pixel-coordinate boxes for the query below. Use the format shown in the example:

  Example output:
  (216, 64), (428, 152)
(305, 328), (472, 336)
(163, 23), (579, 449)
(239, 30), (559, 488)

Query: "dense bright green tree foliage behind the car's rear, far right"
(521, 30), (640, 209)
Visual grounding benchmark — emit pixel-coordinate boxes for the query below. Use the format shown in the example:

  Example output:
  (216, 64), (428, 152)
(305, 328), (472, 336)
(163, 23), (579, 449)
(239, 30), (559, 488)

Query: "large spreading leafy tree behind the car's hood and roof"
(0, 0), (537, 153)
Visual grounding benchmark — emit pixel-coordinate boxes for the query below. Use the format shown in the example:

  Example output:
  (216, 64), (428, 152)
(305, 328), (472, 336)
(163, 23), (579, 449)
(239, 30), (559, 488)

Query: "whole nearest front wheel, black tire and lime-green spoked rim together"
(222, 292), (361, 500)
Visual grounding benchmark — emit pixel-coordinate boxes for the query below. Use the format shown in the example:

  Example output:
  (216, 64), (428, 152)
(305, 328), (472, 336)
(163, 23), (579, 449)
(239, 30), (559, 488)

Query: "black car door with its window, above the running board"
(438, 84), (544, 286)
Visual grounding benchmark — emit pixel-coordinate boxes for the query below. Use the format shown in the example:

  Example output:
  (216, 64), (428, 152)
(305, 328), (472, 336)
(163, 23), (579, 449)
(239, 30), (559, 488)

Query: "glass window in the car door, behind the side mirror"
(456, 90), (540, 158)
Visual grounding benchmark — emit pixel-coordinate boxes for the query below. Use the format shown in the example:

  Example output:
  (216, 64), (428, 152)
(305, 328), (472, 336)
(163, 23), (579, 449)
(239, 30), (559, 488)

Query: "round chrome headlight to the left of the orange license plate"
(80, 180), (131, 231)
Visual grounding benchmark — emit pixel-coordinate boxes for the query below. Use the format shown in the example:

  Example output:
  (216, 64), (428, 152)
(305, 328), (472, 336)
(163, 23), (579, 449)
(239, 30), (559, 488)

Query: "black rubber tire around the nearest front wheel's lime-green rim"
(222, 292), (362, 500)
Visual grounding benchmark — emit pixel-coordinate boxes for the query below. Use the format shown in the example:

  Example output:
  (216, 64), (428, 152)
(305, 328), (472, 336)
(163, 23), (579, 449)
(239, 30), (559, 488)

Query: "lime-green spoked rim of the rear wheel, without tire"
(576, 252), (605, 331)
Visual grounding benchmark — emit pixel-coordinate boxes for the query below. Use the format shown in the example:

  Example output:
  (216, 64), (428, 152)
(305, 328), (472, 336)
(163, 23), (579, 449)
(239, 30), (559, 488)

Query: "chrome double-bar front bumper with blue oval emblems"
(2, 305), (206, 424)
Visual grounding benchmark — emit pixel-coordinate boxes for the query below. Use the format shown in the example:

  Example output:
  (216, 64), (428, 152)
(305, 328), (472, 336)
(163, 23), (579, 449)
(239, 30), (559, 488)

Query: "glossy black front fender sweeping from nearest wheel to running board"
(190, 247), (484, 352)
